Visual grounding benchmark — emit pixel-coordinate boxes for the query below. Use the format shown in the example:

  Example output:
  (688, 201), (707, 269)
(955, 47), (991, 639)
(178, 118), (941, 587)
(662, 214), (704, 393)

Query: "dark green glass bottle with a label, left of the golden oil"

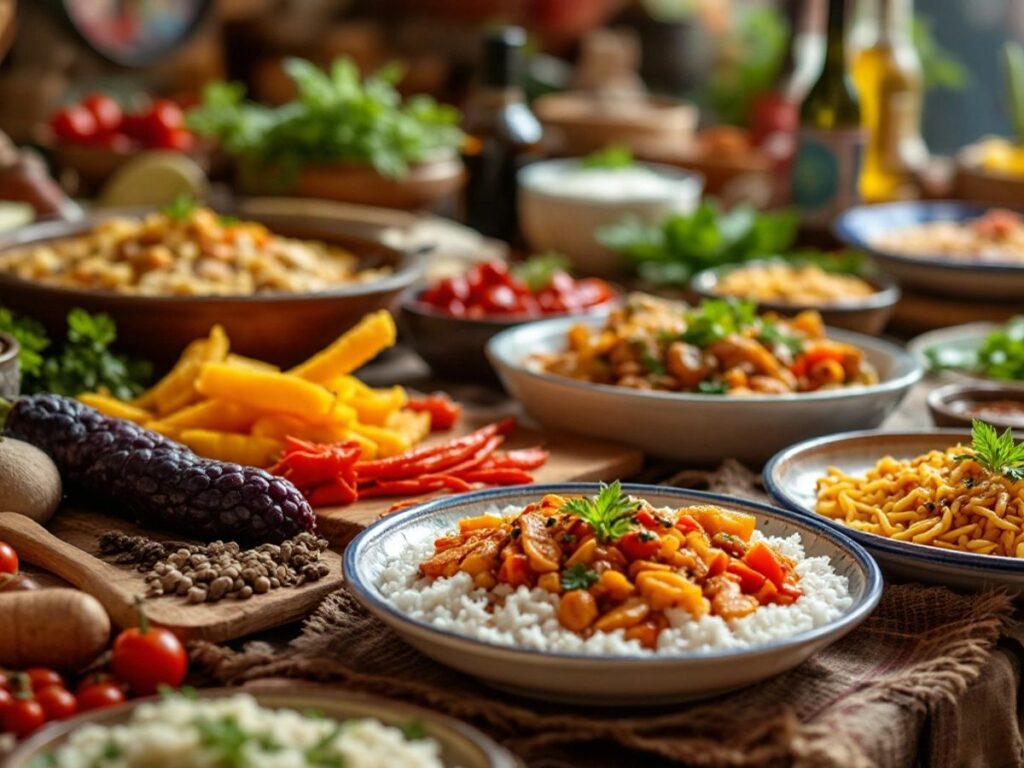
(792, 0), (864, 229)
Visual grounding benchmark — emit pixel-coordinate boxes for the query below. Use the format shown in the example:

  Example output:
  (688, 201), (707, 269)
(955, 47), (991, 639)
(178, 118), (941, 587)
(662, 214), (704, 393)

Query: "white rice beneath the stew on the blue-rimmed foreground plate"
(377, 509), (853, 656)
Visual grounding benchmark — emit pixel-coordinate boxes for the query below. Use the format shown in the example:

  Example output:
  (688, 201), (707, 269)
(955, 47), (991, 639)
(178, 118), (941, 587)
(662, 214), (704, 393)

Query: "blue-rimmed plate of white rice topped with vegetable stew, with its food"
(344, 482), (882, 706)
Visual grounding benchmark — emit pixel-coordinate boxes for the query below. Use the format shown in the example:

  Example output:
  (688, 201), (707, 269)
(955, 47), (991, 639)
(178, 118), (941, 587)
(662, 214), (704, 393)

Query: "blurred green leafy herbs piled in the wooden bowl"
(187, 58), (463, 177)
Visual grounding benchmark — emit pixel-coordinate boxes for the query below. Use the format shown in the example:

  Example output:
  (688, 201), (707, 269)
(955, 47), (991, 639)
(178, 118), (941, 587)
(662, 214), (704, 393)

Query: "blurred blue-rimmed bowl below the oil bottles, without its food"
(833, 201), (1024, 300)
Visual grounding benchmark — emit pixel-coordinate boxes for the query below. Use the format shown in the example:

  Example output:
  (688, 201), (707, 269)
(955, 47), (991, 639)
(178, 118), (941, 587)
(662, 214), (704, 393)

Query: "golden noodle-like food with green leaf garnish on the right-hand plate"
(815, 422), (1024, 557)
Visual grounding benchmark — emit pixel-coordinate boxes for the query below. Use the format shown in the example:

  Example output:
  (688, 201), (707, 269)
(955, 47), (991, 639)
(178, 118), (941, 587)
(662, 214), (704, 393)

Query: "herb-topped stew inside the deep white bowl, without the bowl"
(531, 294), (878, 395)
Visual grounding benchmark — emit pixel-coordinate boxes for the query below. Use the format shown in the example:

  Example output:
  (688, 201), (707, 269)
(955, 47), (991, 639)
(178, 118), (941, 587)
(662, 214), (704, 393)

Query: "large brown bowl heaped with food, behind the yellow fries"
(0, 198), (422, 365)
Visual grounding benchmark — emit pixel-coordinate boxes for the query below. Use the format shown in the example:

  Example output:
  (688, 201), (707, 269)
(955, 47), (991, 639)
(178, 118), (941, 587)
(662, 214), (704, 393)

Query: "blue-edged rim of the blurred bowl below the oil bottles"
(833, 200), (1024, 275)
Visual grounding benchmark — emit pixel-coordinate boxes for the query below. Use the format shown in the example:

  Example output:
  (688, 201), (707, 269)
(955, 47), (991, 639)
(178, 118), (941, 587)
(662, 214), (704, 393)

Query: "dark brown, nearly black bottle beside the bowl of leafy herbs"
(463, 27), (543, 243)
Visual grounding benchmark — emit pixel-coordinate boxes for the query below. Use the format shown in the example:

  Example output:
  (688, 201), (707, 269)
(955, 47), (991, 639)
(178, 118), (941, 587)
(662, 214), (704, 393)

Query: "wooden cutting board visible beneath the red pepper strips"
(316, 410), (643, 548)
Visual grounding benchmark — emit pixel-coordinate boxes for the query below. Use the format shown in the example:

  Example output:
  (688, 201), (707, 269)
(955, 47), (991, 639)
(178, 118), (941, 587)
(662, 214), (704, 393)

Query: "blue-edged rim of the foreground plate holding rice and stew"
(342, 482), (883, 665)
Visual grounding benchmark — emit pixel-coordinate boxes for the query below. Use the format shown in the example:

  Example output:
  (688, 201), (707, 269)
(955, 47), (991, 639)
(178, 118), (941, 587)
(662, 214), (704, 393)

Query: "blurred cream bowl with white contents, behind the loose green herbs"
(518, 160), (703, 276)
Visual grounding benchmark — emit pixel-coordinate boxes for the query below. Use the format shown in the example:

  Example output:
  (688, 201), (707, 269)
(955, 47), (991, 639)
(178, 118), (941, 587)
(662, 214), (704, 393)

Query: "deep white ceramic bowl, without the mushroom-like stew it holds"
(487, 316), (922, 466)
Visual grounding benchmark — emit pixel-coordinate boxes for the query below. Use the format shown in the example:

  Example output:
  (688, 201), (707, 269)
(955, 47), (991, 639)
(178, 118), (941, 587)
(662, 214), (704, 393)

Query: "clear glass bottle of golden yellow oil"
(851, 0), (928, 203)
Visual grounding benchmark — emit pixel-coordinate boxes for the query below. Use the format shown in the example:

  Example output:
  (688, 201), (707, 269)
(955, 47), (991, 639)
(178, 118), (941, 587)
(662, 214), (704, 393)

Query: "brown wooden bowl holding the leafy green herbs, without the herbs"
(237, 155), (466, 210)
